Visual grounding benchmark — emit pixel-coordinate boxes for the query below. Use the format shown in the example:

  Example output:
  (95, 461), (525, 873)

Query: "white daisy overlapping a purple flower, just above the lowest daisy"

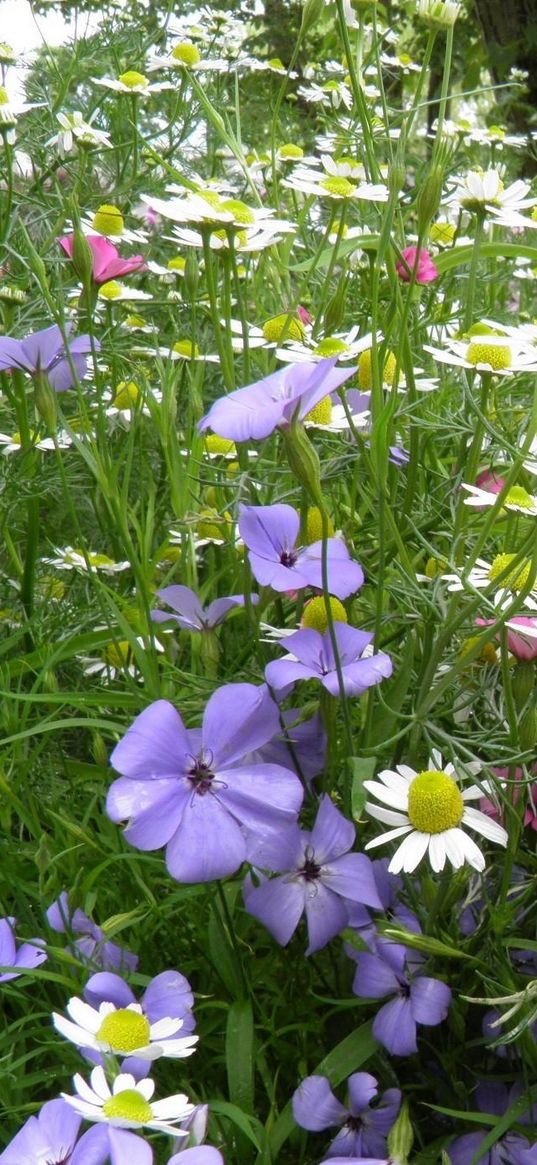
(52, 996), (198, 1060)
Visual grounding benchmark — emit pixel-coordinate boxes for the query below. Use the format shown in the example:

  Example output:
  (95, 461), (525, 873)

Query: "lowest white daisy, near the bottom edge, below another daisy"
(62, 1067), (195, 1137)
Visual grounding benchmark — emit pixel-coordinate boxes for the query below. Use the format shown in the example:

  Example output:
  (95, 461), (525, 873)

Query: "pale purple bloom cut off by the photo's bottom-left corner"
(0, 1100), (82, 1165)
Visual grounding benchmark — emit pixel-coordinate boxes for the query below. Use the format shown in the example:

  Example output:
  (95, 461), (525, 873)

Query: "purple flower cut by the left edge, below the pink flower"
(0, 324), (100, 393)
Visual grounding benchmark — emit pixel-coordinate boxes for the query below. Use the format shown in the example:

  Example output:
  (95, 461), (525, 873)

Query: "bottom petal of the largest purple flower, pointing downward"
(165, 792), (246, 883)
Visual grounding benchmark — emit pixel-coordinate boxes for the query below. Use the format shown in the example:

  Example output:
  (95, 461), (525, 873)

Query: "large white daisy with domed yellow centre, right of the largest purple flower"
(363, 749), (507, 874)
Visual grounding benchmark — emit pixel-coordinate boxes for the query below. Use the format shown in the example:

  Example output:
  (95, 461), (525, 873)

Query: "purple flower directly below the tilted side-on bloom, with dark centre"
(239, 505), (363, 599)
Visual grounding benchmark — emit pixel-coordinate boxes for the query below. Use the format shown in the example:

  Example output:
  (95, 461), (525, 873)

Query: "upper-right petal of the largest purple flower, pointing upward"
(203, 684), (280, 768)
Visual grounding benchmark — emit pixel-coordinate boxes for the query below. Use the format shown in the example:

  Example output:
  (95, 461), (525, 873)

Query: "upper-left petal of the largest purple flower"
(109, 700), (191, 781)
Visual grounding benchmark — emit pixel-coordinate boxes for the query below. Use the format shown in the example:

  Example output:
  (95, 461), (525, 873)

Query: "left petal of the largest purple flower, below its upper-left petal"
(106, 777), (190, 849)
